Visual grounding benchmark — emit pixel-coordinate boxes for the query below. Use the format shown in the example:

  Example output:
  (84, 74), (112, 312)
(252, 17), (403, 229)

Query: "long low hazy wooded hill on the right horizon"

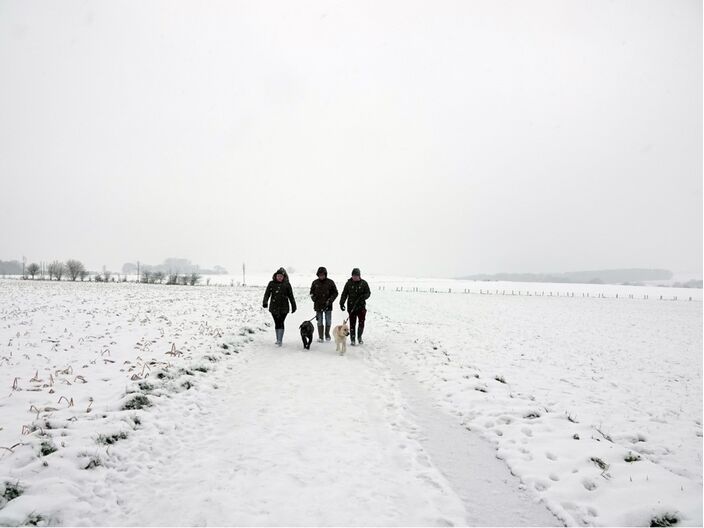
(459, 268), (702, 288)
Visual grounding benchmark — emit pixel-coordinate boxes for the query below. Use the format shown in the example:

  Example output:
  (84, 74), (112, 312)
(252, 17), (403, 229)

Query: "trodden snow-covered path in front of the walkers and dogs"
(86, 330), (560, 526)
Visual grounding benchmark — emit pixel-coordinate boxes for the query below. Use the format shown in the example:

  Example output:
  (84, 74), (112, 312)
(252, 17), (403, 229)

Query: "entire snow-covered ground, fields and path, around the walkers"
(0, 275), (702, 526)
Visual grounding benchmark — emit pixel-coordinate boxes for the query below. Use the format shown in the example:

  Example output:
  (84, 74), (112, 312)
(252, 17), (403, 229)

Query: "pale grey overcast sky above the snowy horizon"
(0, 0), (702, 276)
